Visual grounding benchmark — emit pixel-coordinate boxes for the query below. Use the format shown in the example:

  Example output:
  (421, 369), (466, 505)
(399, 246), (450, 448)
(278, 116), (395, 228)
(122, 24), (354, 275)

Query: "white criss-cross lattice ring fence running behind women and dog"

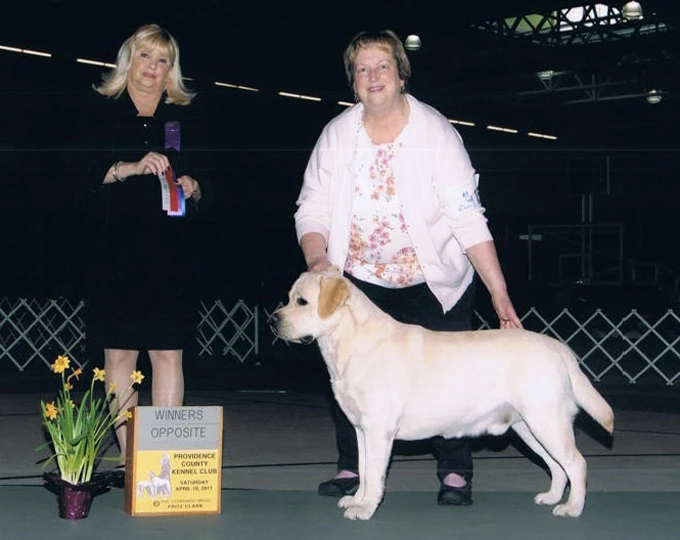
(0, 298), (680, 386)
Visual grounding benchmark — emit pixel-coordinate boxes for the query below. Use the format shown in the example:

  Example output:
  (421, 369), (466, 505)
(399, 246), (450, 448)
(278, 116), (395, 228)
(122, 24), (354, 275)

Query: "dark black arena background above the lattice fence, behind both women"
(0, 0), (680, 388)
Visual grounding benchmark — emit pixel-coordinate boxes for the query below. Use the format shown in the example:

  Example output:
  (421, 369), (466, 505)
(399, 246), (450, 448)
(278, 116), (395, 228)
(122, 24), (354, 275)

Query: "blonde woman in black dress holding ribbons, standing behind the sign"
(86, 24), (206, 466)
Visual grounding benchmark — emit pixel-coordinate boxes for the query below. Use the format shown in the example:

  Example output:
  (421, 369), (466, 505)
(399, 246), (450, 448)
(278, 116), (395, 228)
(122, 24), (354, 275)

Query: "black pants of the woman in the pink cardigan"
(331, 274), (475, 482)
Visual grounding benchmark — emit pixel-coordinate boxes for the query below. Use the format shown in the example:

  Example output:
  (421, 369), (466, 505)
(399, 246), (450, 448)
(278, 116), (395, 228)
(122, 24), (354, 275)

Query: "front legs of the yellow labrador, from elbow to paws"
(338, 427), (393, 519)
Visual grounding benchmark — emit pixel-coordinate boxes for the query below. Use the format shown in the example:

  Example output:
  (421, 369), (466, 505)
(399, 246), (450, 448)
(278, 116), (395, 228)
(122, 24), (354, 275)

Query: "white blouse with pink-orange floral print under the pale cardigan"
(345, 130), (425, 288)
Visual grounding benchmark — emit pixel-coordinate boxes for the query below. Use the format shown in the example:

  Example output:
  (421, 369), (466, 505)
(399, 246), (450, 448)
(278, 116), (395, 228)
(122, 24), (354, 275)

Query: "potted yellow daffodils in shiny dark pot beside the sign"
(38, 356), (144, 519)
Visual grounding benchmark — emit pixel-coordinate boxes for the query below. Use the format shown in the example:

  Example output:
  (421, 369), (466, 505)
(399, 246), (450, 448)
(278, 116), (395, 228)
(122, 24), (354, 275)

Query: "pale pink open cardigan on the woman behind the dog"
(295, 95), (492, 312)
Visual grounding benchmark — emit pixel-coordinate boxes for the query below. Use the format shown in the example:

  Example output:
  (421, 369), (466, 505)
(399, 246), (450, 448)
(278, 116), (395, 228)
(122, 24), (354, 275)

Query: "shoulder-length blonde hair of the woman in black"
(93, 24), (196, 105)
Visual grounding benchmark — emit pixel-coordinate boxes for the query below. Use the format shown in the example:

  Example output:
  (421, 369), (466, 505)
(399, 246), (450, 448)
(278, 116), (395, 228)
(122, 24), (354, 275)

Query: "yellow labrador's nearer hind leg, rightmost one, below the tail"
(525, 412), (587, 517)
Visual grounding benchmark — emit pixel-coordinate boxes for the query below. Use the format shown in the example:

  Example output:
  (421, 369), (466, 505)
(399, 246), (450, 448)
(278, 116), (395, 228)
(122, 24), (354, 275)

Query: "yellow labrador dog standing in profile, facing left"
(274, 271), (614, 519)
